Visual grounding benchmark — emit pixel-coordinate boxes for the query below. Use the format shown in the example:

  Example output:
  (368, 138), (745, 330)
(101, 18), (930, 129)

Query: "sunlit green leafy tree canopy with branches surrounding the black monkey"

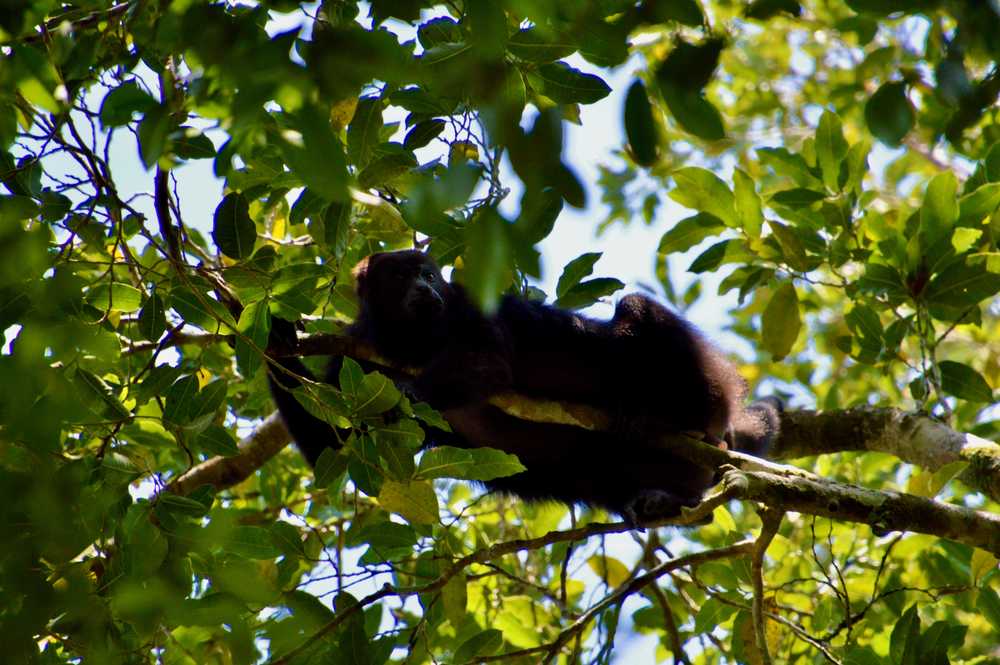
(0, 0), (1000, 665)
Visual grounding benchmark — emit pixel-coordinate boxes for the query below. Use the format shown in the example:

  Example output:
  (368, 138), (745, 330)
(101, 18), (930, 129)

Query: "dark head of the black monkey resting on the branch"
(354, 250), (451, 325)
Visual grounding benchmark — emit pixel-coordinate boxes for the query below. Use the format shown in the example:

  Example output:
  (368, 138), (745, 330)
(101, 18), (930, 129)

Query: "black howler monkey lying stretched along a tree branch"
(270, 250), (781, 524)
